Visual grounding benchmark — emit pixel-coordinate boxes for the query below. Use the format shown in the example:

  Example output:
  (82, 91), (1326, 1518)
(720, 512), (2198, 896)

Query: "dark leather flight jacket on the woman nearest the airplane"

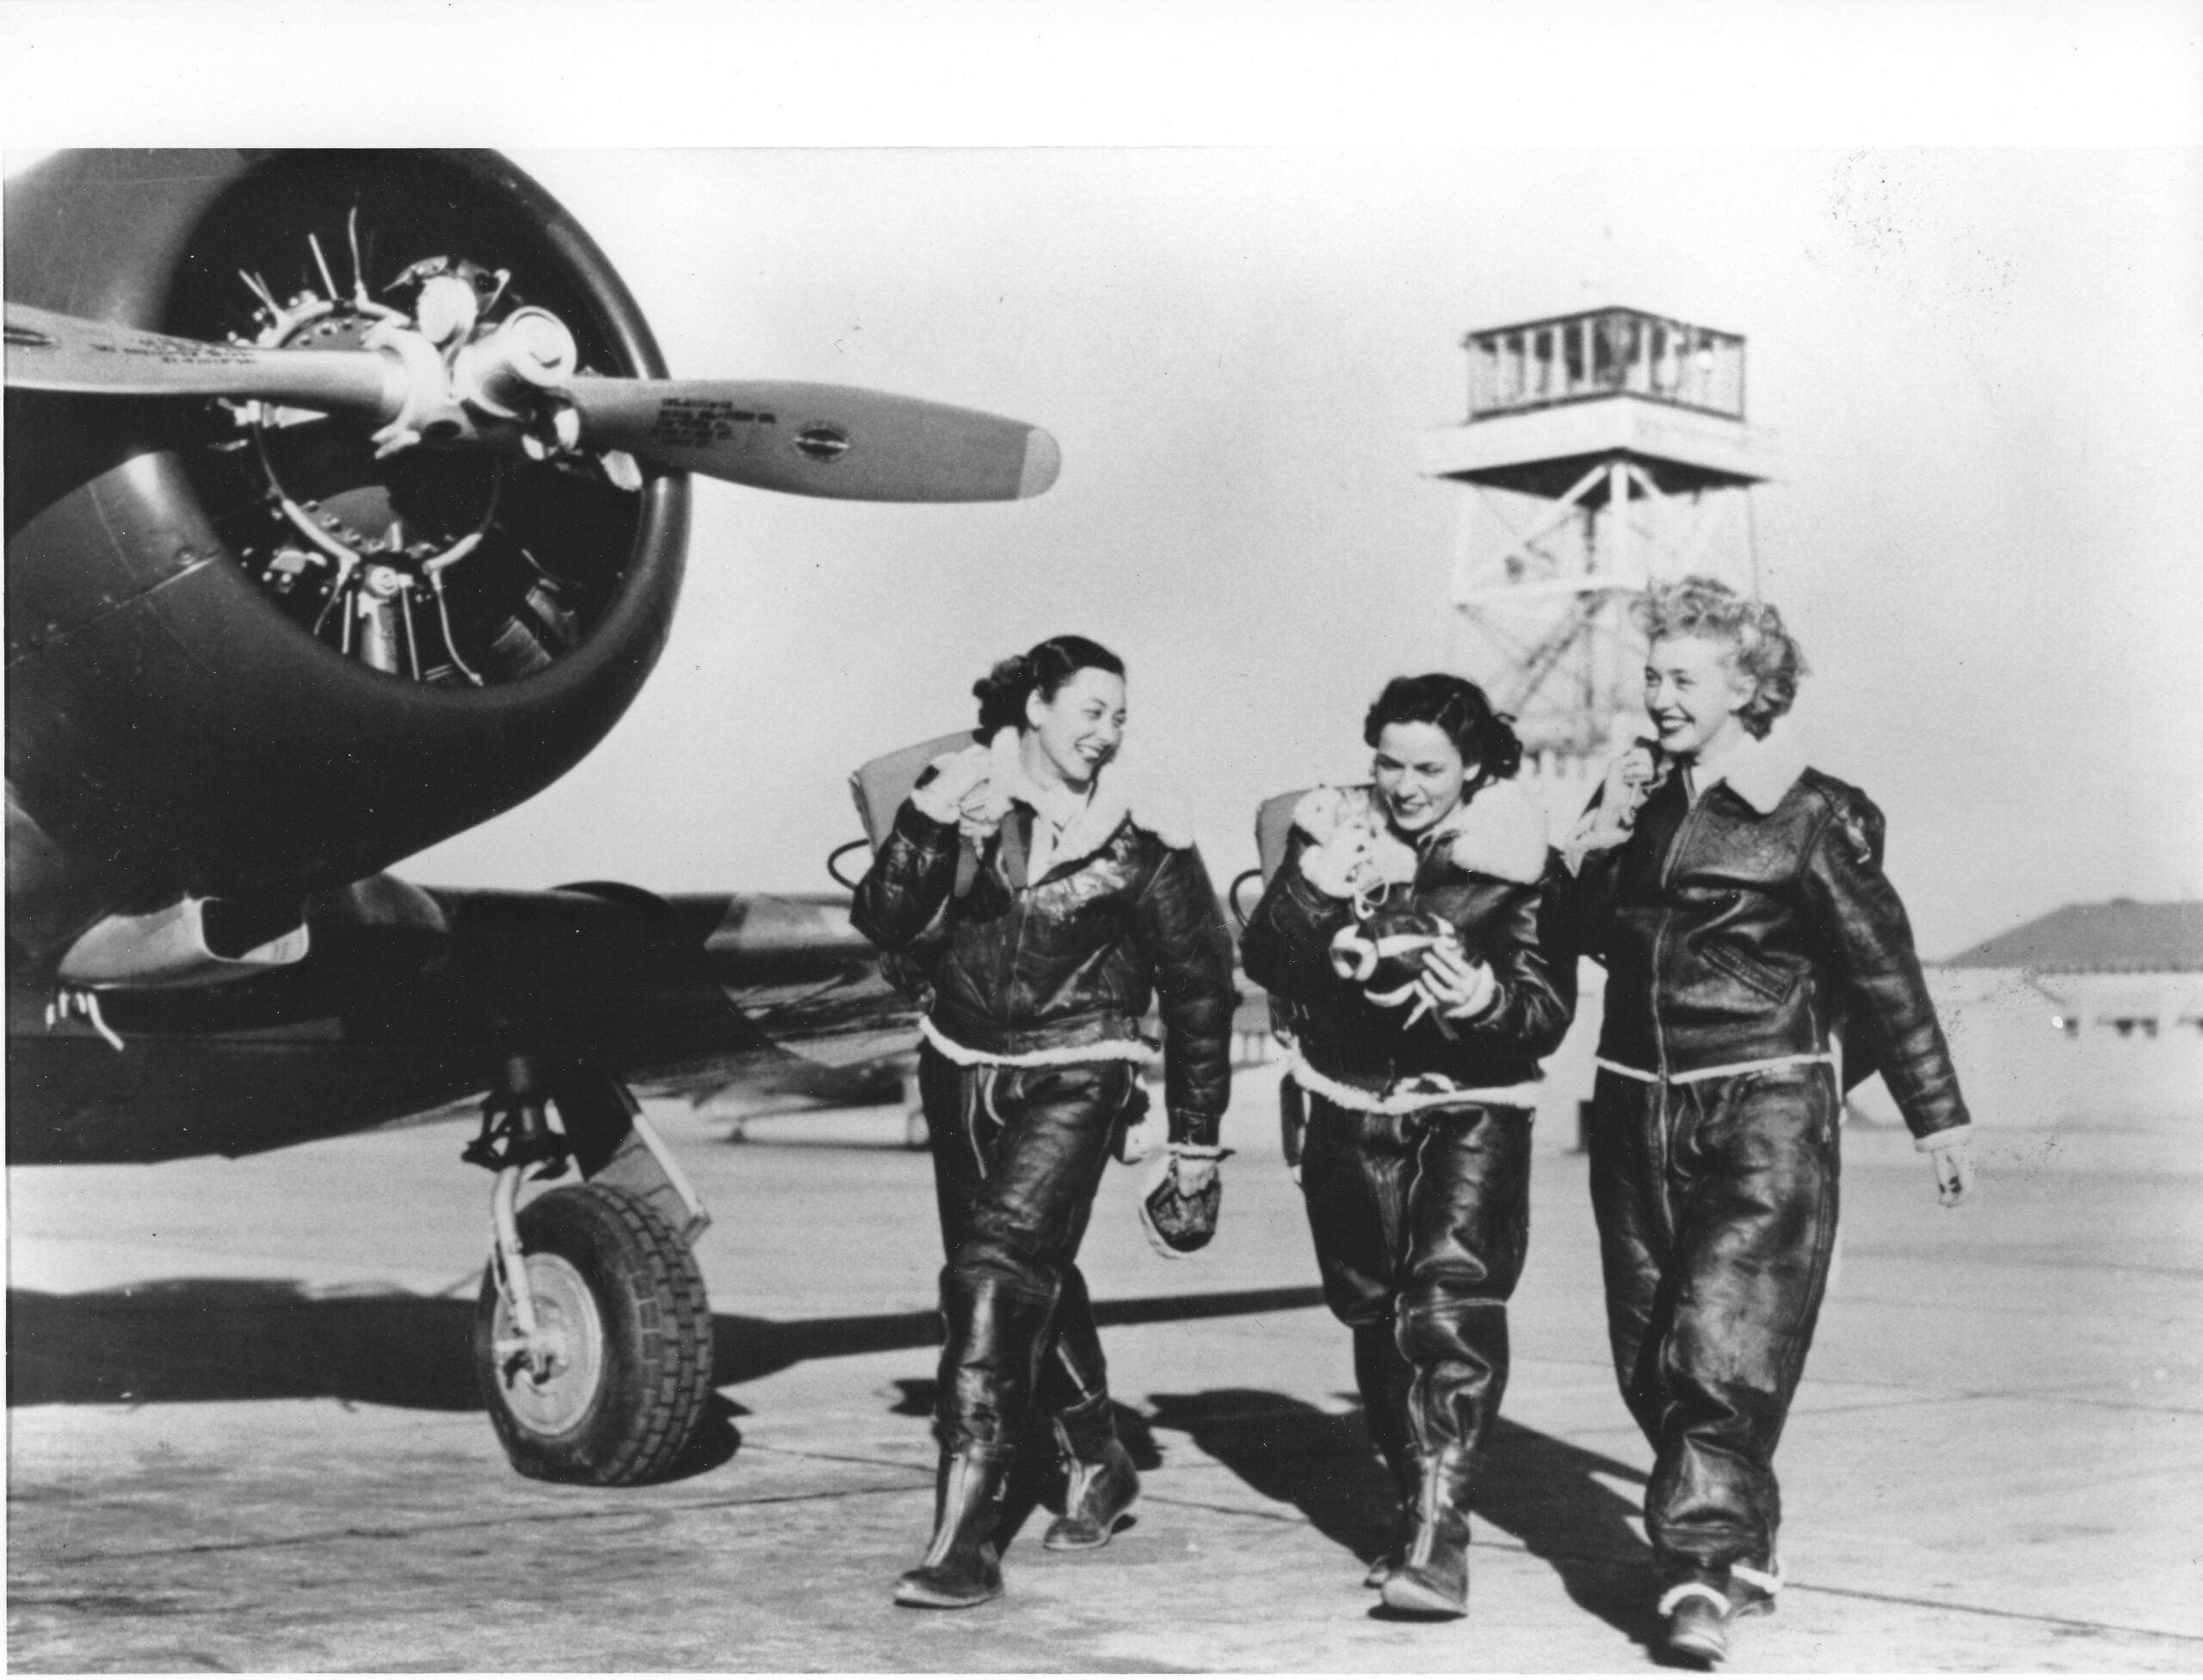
(850, 800), (1238, 1145)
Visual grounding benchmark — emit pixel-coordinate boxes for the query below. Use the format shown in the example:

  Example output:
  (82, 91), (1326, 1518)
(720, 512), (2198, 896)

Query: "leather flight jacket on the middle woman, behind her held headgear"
(1240, 829), (1575, 1091)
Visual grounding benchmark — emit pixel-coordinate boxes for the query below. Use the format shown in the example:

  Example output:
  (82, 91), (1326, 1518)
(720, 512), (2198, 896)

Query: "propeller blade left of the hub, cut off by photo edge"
(7, 305), (405, 419)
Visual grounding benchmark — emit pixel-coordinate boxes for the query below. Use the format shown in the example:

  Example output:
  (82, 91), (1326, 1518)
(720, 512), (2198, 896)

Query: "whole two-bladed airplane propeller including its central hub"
(7, 302), (1062, 503)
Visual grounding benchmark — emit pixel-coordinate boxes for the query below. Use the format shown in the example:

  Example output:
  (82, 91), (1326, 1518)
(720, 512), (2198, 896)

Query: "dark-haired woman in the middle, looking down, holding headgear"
(1240, 675), (1575, 1616)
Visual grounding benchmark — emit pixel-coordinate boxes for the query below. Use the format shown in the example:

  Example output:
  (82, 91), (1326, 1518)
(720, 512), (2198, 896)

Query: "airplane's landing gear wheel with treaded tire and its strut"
(467, 1056), (712, 1486)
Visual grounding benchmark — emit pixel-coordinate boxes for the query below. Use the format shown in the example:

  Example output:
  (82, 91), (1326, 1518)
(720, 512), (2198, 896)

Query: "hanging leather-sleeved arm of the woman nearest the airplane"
(1132, 847), (1238, 1145)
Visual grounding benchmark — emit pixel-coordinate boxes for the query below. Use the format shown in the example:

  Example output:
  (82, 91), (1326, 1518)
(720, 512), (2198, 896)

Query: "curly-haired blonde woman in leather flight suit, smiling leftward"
(1564, 578), (1967, 1663)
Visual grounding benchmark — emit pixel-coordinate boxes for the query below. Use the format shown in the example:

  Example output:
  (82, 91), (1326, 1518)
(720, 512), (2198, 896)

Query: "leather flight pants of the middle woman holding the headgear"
(1299, 1091), (1531, 1486)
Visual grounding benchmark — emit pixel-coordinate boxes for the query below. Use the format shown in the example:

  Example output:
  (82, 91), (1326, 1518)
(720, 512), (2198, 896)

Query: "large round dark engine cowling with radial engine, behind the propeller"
(7, 152), (688, 963)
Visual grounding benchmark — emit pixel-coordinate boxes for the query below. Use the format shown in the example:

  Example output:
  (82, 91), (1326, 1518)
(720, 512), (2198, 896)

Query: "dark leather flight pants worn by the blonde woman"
(1590, 1063), (1842, 1574)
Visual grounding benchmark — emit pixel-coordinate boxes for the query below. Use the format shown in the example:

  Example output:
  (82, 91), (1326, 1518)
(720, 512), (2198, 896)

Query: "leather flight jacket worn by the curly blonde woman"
(1562, 769), (1967, 1138)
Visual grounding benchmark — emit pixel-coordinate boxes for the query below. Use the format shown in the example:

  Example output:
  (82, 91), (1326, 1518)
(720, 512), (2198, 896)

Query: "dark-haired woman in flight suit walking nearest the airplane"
(853, 635), (1234, 1609)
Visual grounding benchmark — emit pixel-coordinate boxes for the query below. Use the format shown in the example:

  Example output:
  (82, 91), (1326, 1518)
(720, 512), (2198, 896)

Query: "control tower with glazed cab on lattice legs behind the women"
(1421, 309), (1767, 794)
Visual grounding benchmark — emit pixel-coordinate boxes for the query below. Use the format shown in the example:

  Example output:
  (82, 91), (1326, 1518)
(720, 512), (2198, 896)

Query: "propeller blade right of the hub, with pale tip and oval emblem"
(566, 377), (1062, 503)
